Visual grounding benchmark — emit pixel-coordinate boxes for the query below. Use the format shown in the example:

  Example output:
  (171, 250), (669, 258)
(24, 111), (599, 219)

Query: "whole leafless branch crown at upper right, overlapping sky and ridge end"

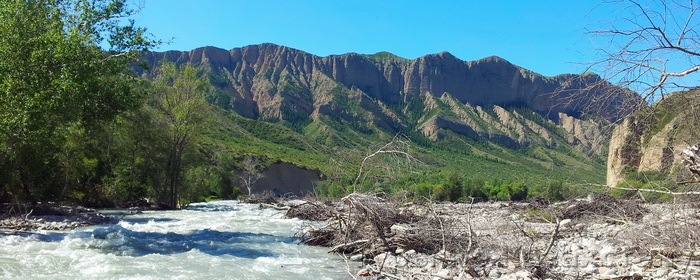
(553, 0), (700, 127)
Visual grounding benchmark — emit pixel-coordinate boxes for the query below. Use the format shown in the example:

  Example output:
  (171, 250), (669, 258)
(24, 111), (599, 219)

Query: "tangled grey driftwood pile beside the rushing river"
(287, 193), (471, 262)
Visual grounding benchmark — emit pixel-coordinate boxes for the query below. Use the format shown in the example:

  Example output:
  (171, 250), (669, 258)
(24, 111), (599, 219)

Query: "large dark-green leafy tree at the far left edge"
(0, 0), (158, 202)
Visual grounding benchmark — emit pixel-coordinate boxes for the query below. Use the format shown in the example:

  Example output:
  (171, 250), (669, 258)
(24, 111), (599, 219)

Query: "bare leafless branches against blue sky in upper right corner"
(588, 0), (700, 106)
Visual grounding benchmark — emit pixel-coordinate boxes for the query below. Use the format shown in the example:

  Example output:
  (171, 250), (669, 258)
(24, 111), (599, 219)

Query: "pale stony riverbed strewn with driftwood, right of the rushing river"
(284, 197), (700, 279)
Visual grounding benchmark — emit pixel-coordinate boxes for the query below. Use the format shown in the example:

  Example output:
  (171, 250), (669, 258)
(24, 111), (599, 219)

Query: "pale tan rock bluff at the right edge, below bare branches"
(607, 90), (700, 186)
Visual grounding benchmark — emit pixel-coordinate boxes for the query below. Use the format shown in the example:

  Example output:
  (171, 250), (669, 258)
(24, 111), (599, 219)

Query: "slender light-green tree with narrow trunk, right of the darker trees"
(153, 63), (209, 208)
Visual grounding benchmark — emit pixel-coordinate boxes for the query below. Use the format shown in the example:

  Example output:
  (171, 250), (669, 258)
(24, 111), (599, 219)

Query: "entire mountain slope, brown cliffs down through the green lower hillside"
(143, 44), (629, 188)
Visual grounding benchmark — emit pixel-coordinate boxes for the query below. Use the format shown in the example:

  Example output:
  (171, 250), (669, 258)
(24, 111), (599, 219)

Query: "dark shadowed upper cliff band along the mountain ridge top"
(139, 43), (624, 120)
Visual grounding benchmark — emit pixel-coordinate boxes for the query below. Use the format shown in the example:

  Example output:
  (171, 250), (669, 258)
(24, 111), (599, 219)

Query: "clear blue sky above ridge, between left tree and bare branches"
(135, 0), (614, 76)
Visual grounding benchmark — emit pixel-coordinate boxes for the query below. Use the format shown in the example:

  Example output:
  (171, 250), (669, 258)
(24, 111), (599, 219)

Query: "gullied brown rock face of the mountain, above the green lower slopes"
(144, 44), (632, 154)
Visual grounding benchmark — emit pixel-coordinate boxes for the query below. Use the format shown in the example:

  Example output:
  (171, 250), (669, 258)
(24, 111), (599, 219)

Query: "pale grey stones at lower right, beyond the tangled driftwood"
(361, 203), (700, 279)
